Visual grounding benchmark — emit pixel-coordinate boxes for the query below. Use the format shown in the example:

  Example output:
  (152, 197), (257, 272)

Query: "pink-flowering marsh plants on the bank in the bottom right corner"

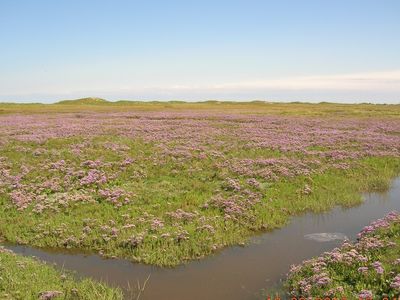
(287, 212), (400, 299)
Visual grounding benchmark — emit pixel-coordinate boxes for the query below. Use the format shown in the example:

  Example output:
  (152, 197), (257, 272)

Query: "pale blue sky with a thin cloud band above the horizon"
(0, 0), (400, 103)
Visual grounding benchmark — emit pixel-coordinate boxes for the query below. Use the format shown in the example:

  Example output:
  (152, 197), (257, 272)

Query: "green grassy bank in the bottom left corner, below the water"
(0, 247), (123, 300)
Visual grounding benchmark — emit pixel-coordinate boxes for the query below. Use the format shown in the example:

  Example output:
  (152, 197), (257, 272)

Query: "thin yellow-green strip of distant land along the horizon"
(0, 101), (400, 117)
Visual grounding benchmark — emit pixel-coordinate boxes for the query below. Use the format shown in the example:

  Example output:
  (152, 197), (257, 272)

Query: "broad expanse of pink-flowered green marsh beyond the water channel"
(0, 103), (400, 266)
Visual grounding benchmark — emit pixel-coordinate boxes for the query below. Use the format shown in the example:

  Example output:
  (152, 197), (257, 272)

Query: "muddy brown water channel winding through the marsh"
(3, 178), (400, 300)
